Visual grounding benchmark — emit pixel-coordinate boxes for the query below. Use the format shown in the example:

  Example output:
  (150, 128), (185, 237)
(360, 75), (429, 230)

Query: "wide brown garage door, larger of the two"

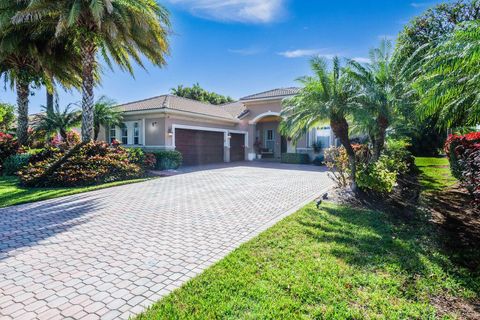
(175, 129), (223, 166)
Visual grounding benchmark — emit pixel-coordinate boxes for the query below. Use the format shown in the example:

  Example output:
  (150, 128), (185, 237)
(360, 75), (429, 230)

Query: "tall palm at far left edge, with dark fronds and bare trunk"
(0, 0), (80, 144)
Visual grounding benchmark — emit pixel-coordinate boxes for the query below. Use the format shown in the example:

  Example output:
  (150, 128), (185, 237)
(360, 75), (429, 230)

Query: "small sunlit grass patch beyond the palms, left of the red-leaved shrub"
(415, 157), (457, 192)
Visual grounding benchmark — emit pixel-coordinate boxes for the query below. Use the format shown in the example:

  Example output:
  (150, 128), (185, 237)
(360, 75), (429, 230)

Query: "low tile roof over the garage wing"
(117, 94), (236, 120)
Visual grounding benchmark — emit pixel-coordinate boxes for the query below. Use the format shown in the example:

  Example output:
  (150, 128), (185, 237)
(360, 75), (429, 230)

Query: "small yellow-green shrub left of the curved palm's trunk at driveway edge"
(324, 147), (350, 188)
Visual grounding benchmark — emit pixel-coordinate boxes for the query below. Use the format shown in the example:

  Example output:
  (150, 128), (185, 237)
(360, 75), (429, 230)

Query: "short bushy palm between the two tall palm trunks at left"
(36, 104), (80, 141)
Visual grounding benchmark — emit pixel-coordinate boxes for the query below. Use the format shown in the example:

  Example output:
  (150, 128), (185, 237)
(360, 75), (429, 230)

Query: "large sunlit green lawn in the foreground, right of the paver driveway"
(138, 204), (480, 319)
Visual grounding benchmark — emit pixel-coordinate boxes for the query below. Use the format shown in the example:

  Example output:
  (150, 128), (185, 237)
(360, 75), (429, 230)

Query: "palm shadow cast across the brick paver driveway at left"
(0, 195), (109, 260)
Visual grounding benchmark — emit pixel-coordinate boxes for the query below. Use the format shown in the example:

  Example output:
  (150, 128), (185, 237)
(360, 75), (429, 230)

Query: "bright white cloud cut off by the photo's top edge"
(168, 0), (285, 23)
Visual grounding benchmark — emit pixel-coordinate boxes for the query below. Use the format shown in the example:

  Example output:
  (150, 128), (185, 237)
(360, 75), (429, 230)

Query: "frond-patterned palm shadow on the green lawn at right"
(300, 205), (480, 308)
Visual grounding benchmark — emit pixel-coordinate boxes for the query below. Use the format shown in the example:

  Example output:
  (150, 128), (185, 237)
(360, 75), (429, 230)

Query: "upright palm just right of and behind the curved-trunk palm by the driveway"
(345, 40), (409, 161)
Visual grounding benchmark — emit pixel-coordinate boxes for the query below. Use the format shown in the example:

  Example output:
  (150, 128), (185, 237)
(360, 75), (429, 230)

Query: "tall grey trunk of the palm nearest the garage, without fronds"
(82, 40), (97, 142)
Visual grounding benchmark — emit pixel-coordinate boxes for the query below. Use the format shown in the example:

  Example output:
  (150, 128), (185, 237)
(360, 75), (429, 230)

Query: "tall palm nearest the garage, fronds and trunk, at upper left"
(15, 0), (170, 141)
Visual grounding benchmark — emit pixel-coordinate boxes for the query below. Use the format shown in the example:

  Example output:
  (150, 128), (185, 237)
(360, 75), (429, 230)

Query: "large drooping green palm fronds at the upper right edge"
(413, 21), (480, 128)
